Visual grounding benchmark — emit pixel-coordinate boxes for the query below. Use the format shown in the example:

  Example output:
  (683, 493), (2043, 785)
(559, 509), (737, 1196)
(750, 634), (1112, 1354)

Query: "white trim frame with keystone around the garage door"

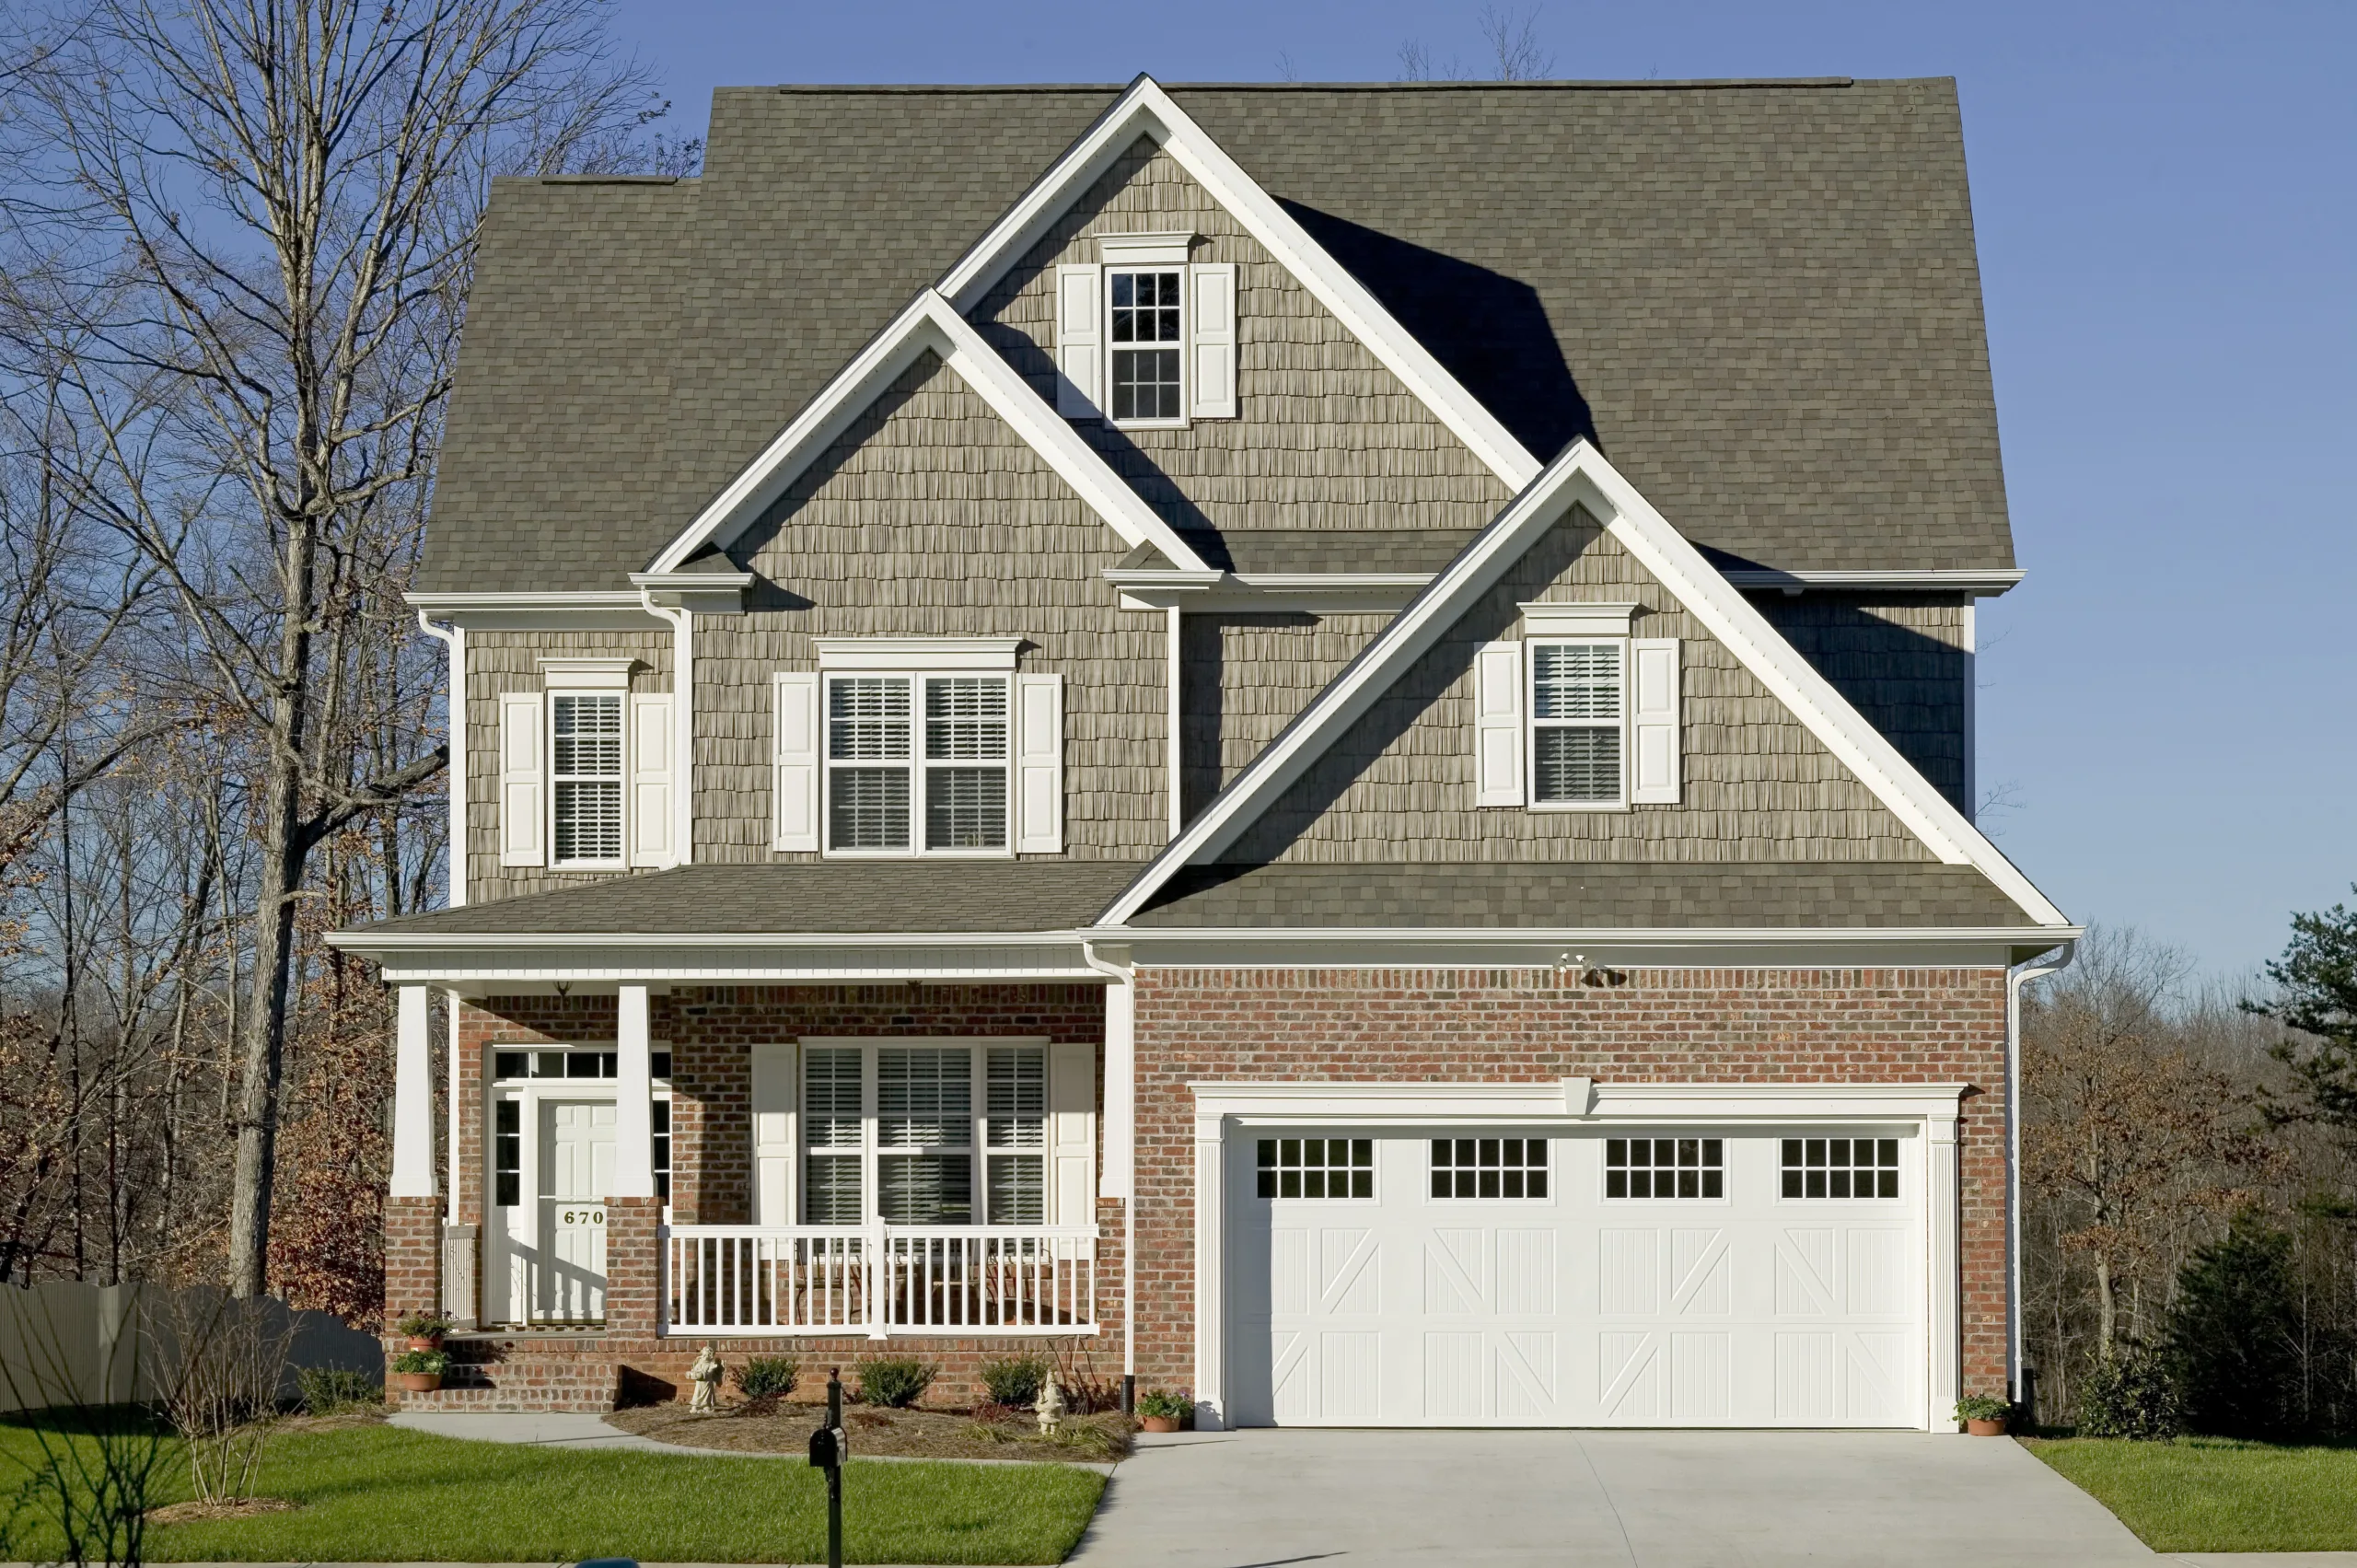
(1188, 1077), (1968, 1431)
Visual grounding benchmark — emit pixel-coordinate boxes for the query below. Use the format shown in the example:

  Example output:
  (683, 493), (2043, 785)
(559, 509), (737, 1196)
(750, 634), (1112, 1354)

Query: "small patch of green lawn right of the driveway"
(2025, 1438), (2357, 1551)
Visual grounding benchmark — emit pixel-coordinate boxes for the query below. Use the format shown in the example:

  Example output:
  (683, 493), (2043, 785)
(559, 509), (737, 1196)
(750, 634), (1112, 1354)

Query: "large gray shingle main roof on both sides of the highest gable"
(417, 80), (2013, 592)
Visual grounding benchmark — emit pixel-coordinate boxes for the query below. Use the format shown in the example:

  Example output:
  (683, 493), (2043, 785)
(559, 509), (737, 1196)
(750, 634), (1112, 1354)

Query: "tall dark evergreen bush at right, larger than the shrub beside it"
(2166, 1212), (2307, 1441)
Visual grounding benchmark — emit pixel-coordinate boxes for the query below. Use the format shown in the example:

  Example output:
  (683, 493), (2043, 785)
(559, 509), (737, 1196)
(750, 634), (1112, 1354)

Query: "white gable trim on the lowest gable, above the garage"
(1098, 438), (2067, 926)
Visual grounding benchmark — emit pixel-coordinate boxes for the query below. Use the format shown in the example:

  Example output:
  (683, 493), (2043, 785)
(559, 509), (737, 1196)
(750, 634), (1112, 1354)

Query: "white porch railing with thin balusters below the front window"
(662, 1222), (1096, 1340)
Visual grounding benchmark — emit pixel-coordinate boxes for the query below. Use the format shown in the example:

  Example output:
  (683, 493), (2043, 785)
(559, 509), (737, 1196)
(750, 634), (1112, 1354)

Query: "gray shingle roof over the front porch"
(361, 861), (1144, 936)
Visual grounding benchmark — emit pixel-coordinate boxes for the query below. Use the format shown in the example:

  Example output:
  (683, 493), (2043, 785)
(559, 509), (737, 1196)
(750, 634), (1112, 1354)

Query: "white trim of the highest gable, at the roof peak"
(938, 73), (1539, 491)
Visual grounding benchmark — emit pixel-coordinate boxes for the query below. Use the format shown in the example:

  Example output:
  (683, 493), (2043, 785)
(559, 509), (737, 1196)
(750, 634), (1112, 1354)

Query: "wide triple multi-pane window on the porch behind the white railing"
(801, 1044), (1047, 1226)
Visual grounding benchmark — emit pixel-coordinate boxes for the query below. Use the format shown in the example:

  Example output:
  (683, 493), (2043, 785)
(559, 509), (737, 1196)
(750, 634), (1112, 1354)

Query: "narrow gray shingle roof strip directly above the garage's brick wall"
(1132, 861), (2034, 929)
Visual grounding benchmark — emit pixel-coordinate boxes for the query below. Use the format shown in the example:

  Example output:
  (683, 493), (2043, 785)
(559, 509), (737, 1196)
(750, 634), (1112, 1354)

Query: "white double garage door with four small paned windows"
(1225, 1127), (1926, 1426)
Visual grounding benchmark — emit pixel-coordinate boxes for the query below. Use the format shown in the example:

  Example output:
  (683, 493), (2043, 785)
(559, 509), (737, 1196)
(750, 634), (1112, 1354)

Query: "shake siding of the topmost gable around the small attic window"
(971, 137), (1506, 530)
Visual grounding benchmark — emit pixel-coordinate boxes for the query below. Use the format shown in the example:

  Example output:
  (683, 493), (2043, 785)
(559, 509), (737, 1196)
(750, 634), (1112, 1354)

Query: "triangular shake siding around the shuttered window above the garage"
(1221, 509), (1933, 863)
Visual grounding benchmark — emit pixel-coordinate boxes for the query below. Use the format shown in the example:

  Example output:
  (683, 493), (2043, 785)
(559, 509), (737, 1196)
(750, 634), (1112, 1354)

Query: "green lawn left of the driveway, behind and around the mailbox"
(0, 1417), (1106, 1563)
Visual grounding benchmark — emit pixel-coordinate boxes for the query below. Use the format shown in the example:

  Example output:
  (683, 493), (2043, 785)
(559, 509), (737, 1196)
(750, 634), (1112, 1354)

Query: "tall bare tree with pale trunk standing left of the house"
(14, 0), (660, 1295)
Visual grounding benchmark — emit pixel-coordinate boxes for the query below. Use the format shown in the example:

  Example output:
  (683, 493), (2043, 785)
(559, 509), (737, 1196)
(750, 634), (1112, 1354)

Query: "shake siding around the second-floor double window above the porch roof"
(695, 354), (1169, 863)
